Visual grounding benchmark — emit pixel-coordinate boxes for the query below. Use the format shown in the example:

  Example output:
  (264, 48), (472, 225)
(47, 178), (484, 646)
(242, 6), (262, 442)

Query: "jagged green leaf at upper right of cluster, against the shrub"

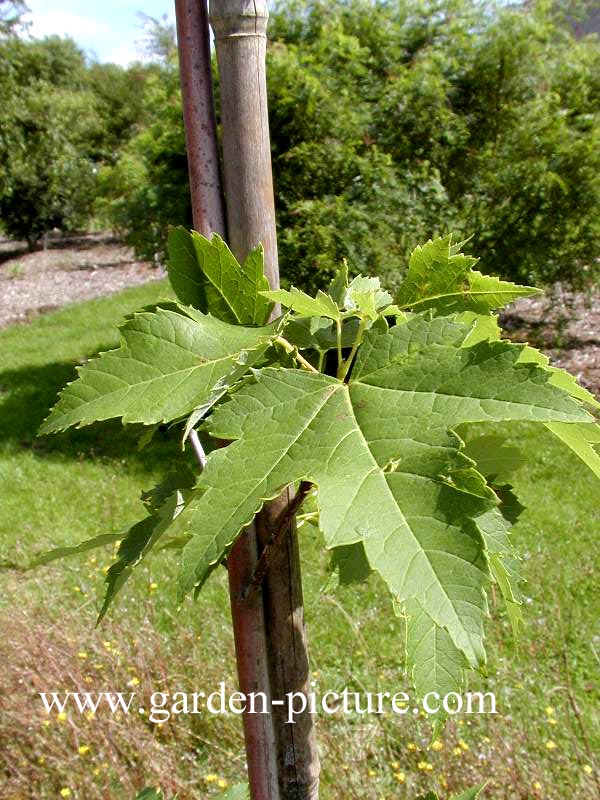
(396, 236), (541, 314)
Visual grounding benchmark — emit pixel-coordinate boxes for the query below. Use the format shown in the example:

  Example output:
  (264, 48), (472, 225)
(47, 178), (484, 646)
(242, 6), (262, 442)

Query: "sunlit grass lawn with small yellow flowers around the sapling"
(0, 283), (600, 800)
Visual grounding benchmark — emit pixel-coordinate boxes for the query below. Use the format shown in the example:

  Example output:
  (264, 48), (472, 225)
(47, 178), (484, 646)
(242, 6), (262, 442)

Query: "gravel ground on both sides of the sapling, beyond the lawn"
(0, 234), (600, 395)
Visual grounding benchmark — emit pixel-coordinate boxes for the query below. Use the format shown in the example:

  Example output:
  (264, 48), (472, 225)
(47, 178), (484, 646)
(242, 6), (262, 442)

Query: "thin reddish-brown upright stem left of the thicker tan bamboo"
(175, 0), (279, 800)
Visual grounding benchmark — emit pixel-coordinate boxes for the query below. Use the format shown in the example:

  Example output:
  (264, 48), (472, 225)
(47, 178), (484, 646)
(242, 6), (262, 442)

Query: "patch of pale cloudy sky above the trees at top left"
(26, 0), (174, 66)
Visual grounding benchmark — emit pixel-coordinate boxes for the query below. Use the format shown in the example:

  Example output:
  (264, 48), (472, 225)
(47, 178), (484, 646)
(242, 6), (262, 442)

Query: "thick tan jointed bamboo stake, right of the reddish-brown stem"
(210, 0), (319, 800)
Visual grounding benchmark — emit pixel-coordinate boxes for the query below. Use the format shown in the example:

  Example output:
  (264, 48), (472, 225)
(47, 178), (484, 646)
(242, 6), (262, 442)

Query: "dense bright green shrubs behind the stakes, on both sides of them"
(96, 0), (600, 288)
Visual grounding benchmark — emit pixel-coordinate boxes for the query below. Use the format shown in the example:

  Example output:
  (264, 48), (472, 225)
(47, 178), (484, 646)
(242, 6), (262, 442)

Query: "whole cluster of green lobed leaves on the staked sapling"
(41, 228), (600, 752)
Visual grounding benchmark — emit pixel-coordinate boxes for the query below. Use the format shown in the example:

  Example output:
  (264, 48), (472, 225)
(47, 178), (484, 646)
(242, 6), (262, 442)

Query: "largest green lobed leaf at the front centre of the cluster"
(175, 315), (588, 666)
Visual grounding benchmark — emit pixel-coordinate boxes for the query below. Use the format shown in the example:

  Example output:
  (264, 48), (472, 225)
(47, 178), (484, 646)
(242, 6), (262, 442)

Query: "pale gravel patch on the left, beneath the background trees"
(0, 234), (165, 328)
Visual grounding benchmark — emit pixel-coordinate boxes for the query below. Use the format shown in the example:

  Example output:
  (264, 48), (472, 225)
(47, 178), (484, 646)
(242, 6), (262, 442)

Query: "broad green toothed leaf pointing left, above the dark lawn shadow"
(40, 308), (275, 434)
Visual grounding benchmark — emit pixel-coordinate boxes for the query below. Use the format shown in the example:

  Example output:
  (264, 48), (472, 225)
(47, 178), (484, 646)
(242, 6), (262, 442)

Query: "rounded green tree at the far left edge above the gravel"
(0, 37), (99, 246)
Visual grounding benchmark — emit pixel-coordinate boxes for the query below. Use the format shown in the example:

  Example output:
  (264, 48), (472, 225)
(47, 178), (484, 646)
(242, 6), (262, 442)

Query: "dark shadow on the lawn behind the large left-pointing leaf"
(0, 362), (181, 471)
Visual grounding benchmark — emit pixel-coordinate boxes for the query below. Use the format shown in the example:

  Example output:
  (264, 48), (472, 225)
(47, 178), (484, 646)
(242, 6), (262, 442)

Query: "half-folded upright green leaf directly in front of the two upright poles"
(168, 228), (272, 325)
